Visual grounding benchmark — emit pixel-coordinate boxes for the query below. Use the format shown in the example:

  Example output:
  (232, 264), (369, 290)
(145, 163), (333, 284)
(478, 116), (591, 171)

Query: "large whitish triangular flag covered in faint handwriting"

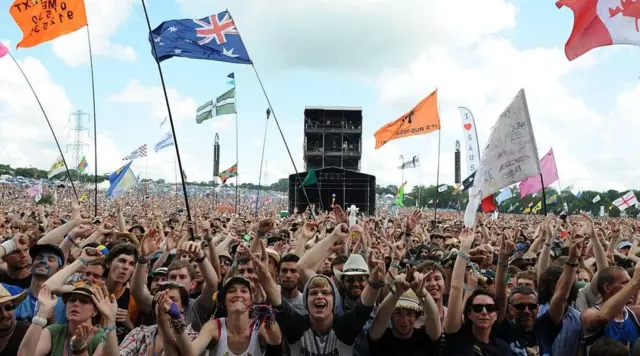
(464, 89), (540, 227)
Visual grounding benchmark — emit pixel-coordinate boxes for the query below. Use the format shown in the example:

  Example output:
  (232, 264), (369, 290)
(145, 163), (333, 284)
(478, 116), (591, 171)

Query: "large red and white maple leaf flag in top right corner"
(556, 0), (640, 61)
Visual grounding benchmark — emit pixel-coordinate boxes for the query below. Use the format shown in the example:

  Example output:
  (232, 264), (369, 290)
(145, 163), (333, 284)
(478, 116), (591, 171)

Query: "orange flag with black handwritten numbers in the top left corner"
(9, 0), (87, 48)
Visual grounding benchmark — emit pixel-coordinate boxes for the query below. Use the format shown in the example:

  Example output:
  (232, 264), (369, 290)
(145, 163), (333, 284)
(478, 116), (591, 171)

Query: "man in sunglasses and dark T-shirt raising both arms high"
(494, 229), (582, 355)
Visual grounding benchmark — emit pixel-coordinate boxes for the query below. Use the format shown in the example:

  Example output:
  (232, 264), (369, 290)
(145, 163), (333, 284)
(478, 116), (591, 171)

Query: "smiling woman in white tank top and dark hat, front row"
(171, 277), (282, 356)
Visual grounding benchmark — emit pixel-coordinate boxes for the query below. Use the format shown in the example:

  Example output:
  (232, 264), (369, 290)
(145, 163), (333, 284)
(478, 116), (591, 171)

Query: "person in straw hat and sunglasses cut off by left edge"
(0, 284), (29, 356)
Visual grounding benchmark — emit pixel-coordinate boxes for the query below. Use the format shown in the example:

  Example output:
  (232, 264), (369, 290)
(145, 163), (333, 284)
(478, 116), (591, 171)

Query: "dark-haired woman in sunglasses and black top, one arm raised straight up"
(441, 229), (512, 356)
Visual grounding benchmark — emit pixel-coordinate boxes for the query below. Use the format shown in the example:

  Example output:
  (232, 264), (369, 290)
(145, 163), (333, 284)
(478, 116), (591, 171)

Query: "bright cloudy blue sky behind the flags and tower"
(0, 0), (640, 190)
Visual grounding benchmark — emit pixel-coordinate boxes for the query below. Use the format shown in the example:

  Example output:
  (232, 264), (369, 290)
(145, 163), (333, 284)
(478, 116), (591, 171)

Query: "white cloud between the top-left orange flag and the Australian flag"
(52, 0), (136, 67)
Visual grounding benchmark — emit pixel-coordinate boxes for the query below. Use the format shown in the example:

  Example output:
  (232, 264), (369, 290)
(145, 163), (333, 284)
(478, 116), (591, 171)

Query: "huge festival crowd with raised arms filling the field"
(0, 182), (640, 356)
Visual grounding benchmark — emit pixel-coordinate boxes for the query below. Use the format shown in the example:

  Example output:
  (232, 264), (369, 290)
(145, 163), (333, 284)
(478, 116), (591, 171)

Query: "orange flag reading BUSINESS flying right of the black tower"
(374, 89), (440, 149)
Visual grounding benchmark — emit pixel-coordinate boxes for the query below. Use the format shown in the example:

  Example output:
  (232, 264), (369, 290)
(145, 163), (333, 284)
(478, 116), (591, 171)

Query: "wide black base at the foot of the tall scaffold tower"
(289, 167), (376, 215)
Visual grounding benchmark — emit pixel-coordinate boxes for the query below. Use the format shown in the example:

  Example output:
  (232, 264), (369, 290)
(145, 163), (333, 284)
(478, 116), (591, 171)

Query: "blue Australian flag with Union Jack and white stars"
(149, 11), (251, 64)
